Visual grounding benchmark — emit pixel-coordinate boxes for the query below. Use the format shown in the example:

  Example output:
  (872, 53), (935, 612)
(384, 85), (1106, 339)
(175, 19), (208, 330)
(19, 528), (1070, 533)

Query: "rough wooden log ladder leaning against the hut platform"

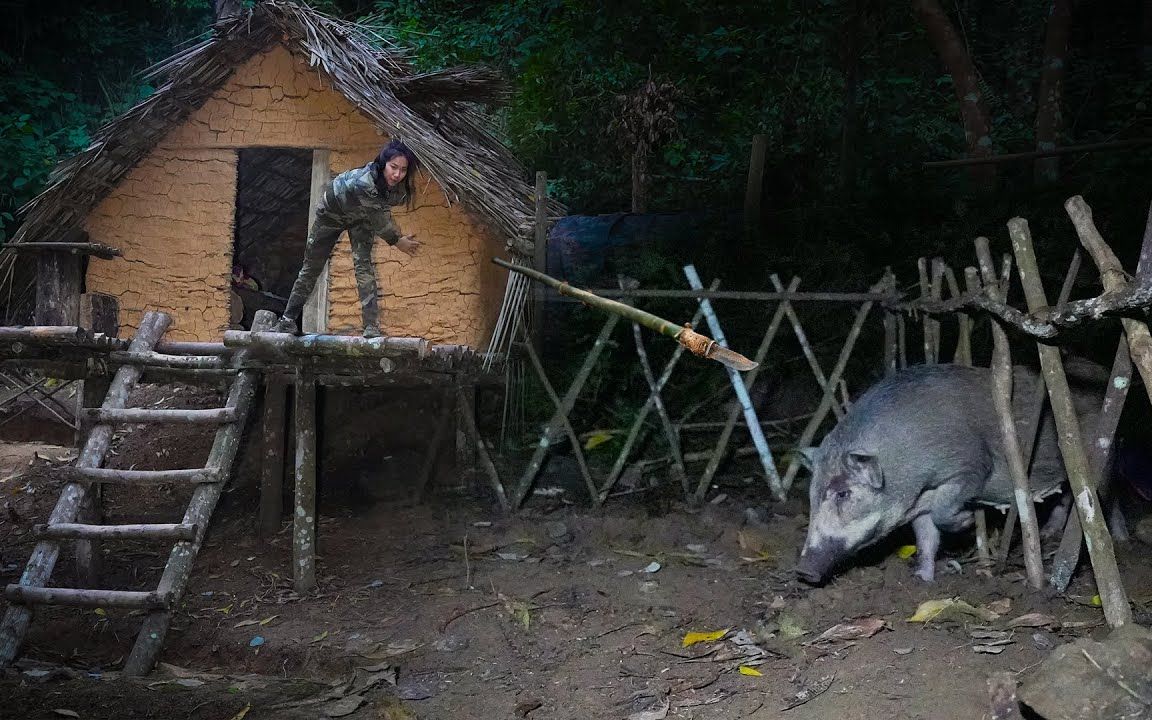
(0, 311), (274, 675)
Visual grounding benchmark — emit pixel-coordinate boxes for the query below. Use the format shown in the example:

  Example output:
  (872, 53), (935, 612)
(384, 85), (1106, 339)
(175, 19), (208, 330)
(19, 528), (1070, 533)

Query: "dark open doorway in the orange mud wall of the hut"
(232, 147), (312, 329)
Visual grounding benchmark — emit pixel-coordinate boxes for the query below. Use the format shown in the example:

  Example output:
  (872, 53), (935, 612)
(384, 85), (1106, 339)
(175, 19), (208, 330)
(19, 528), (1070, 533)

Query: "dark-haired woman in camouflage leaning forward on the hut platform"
(273, 141), (420, 338)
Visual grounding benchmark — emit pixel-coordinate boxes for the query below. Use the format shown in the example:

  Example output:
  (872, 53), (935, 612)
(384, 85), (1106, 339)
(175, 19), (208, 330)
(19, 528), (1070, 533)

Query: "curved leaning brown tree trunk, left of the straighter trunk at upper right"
(912, 0), (996, 190)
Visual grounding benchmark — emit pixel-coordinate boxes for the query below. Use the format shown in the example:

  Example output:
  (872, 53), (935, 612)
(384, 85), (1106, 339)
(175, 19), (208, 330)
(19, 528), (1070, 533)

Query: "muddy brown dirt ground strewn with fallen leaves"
(0, 388), (1152, 720)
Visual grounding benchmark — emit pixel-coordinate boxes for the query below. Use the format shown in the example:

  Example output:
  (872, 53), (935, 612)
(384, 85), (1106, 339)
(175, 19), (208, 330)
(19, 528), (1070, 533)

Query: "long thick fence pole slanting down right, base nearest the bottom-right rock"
(1008, 218), (1132, 628)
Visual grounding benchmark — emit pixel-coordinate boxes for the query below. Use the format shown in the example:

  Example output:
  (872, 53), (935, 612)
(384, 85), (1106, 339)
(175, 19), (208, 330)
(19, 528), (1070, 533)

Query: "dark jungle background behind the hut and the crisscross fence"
(0, 0), (1152, 460)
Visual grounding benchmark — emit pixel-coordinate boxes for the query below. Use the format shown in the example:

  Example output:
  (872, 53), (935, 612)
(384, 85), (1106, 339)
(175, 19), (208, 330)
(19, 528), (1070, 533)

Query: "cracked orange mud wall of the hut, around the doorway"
(85, 45), (506, 347)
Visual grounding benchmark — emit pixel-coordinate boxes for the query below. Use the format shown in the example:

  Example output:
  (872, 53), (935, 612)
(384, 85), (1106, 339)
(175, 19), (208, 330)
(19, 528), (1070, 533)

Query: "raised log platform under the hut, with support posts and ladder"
(0, 322), (508, 674)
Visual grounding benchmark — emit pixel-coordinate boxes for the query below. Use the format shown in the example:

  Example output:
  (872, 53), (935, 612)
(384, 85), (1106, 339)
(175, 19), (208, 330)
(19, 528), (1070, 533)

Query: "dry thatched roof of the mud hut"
(12, 0), (564, 256)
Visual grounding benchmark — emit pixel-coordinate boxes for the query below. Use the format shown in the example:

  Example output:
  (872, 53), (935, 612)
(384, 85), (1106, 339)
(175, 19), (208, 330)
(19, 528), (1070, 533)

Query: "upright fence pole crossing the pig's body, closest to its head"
(976, 237), (1044, 590)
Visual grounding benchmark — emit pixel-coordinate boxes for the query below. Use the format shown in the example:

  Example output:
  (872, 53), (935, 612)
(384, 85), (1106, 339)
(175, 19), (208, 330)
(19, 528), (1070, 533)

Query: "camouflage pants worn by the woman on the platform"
(283, 215), (380, 327)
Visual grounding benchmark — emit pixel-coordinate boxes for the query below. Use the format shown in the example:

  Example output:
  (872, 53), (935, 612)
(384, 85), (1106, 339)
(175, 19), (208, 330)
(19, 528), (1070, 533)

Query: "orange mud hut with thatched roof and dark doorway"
(3, 1), (562, 348)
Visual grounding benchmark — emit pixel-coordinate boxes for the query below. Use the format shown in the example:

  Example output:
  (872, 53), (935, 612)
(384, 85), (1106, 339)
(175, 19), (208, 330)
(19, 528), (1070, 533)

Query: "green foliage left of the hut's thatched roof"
(0, 0), (211, 242)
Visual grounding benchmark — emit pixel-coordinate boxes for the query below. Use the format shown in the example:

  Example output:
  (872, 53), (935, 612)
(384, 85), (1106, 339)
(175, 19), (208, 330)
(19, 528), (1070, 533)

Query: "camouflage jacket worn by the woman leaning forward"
(316, 162), (407, 245)
